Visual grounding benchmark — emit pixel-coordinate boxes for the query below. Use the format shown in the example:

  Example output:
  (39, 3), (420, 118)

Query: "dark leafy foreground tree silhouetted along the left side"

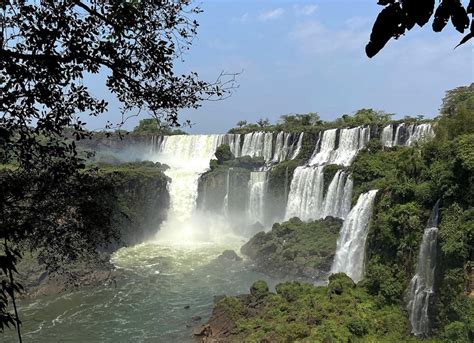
(0, 0), (235, 338)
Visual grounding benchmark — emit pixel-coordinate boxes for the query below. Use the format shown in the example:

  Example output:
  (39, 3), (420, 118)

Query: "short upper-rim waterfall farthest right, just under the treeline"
(380, 123), (434, 147)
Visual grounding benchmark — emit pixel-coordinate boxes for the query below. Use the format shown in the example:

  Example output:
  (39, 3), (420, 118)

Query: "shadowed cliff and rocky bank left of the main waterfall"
(18, 162), (169, 298)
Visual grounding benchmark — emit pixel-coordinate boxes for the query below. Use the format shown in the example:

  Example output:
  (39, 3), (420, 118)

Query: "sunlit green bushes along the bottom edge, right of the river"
(211, 273), (430, 342)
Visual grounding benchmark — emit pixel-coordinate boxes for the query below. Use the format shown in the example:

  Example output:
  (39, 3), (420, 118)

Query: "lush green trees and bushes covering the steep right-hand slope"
(351, 85), (474, 342)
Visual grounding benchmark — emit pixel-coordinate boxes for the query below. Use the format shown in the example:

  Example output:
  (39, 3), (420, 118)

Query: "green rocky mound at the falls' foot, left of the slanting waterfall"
(241, 218), (342, 279)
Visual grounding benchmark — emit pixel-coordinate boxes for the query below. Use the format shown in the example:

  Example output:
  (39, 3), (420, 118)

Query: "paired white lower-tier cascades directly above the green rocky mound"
(285, 166), (352, 220)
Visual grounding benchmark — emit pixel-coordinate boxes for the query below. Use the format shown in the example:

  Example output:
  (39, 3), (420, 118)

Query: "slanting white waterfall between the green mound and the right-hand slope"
(331, 190), (377, 282)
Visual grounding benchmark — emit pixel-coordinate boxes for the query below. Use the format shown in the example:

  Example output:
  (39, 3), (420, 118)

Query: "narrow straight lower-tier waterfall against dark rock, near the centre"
(248, 171), (267, 224)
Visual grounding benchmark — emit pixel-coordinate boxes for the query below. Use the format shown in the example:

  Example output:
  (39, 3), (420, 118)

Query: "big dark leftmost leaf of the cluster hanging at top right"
(365, 3), (406, 57)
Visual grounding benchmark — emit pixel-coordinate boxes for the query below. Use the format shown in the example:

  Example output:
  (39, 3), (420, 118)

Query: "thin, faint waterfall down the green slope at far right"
(407, 201), (439, 336)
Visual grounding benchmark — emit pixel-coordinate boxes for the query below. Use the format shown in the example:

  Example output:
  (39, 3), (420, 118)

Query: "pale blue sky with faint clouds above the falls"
(83, 0), (474, 134)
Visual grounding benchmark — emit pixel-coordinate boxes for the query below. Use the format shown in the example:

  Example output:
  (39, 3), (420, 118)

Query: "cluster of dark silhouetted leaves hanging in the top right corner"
(365, 0), (474, 57)
